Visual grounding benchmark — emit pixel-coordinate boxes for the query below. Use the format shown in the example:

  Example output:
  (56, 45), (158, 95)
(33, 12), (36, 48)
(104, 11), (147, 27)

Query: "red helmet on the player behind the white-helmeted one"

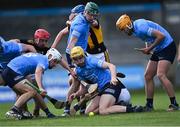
(34, 29), (50, 40)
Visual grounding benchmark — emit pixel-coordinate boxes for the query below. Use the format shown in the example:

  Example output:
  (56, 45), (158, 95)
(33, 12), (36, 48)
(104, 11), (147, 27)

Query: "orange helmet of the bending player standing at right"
(116, 14), (132, 30)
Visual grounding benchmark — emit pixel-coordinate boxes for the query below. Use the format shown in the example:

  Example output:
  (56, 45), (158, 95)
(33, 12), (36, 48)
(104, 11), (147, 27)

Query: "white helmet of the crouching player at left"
(46, 48), (62, 61)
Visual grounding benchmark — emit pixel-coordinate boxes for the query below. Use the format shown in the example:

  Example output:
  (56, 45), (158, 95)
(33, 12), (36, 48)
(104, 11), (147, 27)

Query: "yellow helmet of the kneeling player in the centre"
(70, 46), (85, 59)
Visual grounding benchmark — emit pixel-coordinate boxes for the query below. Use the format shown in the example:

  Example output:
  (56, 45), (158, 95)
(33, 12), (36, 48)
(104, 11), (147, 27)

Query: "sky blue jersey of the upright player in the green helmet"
(66, 13), (90, 53)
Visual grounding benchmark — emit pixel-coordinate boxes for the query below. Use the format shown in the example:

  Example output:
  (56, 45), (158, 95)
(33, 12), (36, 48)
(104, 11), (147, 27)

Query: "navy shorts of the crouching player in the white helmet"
(2, 67), (25, 88)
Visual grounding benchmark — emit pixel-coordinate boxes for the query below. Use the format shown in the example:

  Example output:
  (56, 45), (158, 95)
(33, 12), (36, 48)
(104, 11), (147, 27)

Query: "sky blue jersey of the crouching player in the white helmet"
(7, 53), (49, 76)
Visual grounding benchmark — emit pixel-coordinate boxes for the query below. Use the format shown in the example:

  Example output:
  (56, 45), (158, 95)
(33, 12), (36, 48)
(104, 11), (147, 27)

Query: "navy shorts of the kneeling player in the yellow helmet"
(99, 80), (126, 103)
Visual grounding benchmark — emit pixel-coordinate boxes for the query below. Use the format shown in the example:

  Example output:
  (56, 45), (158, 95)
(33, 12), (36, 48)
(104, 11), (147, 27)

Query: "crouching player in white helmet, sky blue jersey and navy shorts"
(1, 49), (63, 119)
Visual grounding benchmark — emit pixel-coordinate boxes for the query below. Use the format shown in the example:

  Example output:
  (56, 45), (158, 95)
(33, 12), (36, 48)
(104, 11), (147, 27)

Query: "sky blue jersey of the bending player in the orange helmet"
(133, 19), (173, 52)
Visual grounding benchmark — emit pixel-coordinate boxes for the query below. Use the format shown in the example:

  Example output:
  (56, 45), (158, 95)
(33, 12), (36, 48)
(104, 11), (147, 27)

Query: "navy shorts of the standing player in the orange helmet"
(150, 42), (176, 64)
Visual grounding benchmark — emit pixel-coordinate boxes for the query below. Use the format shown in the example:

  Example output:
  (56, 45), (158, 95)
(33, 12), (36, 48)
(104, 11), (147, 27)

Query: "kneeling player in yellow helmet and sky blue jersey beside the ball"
(70, 46), (142, 115)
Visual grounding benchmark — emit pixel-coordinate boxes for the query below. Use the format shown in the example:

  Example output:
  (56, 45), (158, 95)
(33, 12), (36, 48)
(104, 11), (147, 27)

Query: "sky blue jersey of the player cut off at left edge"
(0, 37), (22, 69)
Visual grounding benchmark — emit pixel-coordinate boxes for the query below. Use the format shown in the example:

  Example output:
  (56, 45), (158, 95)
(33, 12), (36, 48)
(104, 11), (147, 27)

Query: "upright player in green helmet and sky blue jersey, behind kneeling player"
(66, 2), (99, 65)
